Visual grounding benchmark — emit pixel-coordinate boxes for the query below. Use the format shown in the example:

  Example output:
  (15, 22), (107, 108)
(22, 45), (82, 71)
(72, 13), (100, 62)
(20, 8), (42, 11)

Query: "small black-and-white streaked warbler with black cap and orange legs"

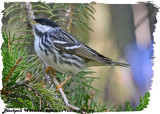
(27, 17), (129, 88)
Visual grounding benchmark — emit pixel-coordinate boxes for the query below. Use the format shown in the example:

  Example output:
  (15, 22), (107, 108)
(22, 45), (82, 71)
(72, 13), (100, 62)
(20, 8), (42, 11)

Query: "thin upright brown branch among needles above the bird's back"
(67, 3), (73, 33)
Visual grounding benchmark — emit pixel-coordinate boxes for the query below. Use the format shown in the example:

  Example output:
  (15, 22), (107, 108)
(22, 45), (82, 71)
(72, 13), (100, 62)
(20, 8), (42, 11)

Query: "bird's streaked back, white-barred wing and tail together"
(51, 28), (128, 66)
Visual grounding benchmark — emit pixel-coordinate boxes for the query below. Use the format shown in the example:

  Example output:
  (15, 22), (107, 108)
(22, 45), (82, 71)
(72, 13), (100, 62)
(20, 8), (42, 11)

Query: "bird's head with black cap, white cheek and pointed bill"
(27, 17), (59, 33)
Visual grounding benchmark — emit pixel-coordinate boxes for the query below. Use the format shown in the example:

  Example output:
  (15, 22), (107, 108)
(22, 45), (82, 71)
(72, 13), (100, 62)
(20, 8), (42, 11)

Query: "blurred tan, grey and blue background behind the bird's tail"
(2, 3), (157, 106)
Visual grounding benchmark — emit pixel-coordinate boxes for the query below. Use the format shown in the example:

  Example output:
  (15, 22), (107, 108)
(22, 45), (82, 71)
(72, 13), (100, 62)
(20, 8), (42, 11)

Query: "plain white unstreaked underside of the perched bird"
(34, 35), (85, 74)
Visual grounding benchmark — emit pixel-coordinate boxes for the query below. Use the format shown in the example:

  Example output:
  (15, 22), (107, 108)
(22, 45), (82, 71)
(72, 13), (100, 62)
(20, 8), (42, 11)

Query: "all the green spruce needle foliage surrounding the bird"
(1, 2), (149, 112)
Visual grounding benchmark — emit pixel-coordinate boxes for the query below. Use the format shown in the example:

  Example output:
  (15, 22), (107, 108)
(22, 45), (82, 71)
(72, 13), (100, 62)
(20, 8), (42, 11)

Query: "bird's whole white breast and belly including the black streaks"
(34, 35), (85, 73)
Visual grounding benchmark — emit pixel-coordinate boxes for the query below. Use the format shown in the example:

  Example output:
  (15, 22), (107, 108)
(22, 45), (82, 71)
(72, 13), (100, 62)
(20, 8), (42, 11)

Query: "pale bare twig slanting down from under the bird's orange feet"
(49, 70), (85, 114)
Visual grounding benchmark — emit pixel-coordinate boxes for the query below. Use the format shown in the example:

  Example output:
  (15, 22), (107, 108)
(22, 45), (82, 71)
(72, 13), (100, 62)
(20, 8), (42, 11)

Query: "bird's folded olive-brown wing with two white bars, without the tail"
(53, 40), (115, 65)
